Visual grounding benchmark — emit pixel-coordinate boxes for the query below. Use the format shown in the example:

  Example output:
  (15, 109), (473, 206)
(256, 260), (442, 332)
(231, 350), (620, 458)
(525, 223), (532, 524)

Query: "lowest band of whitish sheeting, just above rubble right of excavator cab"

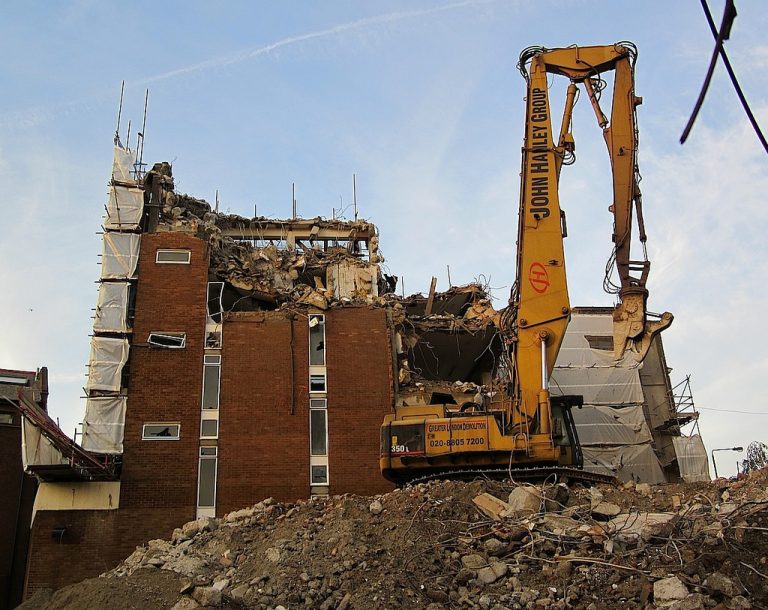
(582, 445), (666, 485)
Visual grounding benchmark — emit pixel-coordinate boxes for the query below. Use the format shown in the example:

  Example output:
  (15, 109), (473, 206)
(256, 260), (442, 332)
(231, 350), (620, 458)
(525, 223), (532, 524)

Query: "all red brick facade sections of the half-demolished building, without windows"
(27, 233), (393, 595)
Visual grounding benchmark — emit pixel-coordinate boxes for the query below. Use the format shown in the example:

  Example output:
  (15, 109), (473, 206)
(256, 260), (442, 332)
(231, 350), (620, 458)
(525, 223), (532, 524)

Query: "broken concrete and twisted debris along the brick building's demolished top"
(146, 163), (505, 410)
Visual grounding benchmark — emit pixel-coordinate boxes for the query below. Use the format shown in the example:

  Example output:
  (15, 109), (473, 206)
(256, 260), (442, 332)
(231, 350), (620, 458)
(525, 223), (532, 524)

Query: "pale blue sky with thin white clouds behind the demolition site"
(0, 0), (768, 473)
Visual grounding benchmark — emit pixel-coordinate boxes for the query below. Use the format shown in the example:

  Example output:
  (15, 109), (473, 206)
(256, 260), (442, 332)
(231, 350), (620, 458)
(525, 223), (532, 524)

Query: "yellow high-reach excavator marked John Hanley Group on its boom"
(380, 42), (672, 483)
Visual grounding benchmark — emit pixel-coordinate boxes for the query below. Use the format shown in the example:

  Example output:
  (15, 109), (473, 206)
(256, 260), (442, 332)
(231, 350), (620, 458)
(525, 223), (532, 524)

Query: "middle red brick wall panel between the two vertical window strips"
(216, 312), (309, 508)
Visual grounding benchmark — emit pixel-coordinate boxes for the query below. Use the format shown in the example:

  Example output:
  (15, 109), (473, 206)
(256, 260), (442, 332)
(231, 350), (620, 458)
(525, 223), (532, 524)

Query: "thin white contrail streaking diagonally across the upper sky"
(0, 0), (500, 129)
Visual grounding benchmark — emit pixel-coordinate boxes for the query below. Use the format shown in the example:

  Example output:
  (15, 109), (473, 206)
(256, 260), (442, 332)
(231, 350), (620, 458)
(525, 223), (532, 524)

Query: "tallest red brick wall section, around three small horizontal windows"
(120, 233), (208, 510)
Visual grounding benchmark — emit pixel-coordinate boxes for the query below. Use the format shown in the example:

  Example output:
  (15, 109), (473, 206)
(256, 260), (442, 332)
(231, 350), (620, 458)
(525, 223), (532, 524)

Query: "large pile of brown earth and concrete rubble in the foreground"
(23, 470), (768, 610)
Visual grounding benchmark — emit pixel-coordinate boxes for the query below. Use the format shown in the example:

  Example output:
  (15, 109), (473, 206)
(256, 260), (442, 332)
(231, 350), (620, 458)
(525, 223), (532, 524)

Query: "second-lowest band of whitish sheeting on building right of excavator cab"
(571, 405), (653, 445)
